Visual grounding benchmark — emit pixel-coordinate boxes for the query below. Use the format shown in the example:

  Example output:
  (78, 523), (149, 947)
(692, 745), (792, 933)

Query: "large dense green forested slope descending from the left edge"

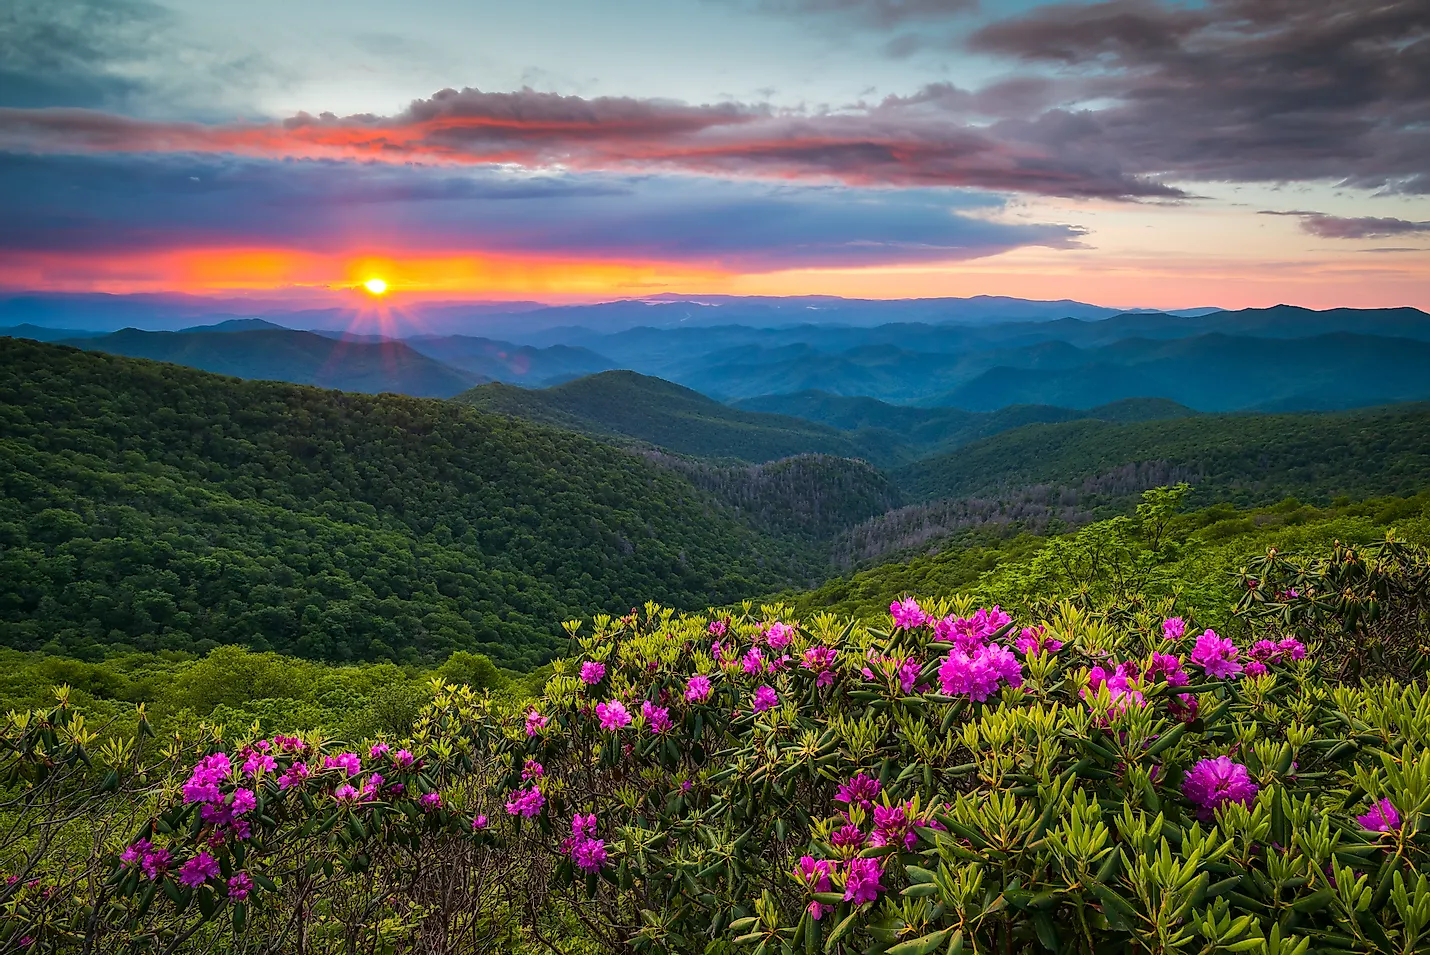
(0, 339), (808, 665)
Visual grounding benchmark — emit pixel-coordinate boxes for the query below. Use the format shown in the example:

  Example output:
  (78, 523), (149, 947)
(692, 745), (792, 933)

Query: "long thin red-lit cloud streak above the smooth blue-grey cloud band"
(0, 89), (1181, 199)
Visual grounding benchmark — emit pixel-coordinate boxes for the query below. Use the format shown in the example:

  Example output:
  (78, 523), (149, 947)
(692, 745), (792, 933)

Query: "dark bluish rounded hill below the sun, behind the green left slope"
(55, 323), (483, 397)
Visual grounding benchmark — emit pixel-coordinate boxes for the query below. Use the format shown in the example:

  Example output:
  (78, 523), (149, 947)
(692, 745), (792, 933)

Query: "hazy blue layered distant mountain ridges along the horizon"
(0, 296), (1430, 412)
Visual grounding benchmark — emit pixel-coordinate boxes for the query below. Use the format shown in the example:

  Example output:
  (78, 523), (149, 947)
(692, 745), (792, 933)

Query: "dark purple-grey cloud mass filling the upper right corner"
(967, 0), (1430, 193)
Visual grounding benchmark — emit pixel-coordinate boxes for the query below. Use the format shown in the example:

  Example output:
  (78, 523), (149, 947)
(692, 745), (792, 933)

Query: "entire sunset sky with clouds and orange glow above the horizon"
(0, 0), (1430, 307)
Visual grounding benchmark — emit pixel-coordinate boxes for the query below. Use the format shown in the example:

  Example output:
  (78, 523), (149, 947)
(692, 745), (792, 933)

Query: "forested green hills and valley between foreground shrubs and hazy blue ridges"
(0, 331), (1430, 665)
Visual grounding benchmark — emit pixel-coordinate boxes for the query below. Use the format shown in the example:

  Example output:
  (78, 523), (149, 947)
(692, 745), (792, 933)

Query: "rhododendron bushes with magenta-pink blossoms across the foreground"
(8, 540), (1430, 955)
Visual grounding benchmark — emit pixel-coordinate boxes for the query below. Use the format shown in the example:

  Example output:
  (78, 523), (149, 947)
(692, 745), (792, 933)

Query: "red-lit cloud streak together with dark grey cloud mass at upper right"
(0, 0), (1430, 200)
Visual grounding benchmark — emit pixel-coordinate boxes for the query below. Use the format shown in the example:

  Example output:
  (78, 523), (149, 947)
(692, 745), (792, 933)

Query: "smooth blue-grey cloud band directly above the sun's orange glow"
(0, 156), (1081, 272)
